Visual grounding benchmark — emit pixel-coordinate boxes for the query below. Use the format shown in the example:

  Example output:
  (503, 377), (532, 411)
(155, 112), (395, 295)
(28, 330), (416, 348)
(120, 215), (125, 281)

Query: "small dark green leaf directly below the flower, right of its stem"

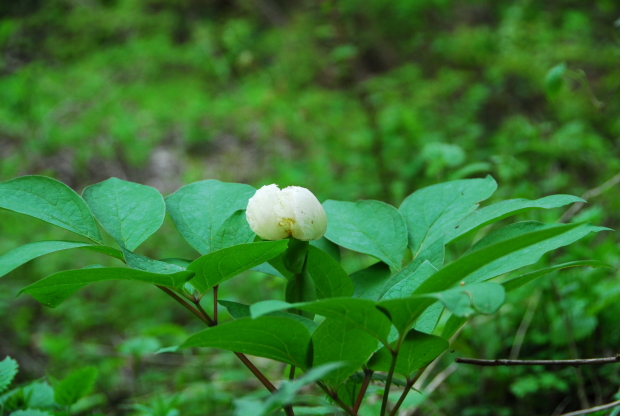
(306, 246), (354, 299)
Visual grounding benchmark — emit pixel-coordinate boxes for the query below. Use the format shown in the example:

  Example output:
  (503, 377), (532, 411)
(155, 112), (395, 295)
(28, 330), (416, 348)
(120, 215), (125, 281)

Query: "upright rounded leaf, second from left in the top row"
(82, 178), (166, 251)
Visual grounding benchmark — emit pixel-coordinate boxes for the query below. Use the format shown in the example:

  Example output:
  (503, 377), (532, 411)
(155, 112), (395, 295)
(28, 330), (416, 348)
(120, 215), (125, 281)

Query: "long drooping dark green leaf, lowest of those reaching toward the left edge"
(19, 267), (194, 308)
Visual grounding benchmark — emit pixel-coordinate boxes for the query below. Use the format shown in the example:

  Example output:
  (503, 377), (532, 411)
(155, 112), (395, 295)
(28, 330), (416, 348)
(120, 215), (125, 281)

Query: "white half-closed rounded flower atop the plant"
(246, 184), (327, 241)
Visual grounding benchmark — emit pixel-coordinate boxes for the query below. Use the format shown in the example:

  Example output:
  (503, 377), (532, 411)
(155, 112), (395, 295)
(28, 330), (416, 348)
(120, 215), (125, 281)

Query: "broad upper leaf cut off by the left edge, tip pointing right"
(0, 176), (103, 244)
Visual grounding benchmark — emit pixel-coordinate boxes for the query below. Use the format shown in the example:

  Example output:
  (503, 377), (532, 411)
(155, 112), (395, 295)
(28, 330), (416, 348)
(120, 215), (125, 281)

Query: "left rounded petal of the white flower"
(245, 184), (290, 240)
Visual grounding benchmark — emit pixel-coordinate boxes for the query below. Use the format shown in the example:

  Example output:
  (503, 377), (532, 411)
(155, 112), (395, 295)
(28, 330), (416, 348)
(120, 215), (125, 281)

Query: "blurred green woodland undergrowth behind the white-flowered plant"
(0, 0), (620, 416)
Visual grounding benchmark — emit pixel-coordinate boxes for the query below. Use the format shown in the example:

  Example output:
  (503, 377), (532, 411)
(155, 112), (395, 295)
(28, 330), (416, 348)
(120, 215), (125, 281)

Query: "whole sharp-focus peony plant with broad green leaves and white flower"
(0, 176), (609, 416)
